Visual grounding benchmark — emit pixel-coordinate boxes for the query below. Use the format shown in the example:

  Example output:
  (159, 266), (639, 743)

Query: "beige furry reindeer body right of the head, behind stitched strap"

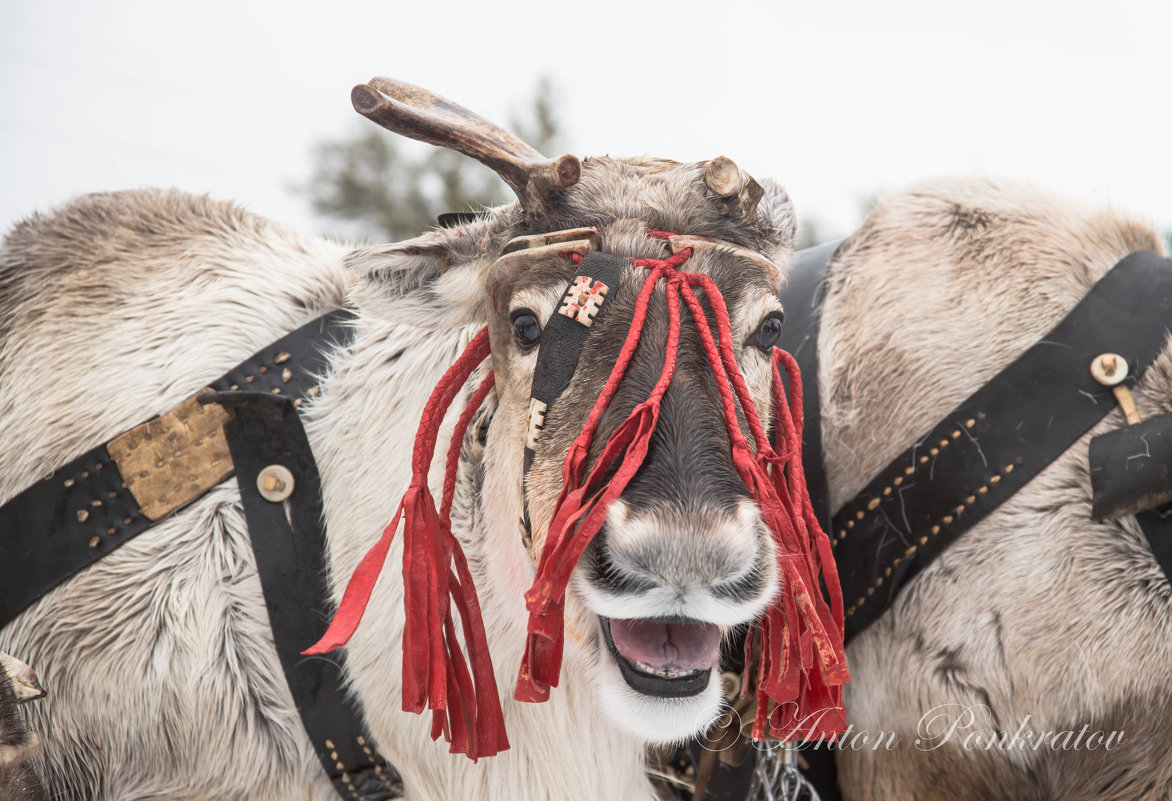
(819, 181), (1172, 800)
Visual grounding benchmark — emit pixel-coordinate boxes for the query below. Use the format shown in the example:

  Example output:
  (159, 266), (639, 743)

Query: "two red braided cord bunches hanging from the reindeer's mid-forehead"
(516, 239), (847, 738)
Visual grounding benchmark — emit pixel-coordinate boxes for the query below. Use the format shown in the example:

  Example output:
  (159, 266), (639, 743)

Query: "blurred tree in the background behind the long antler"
(300, 77), (560, 242)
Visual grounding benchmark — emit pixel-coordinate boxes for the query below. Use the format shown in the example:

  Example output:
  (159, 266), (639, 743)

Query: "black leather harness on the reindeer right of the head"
(759, 242), (1172, 801)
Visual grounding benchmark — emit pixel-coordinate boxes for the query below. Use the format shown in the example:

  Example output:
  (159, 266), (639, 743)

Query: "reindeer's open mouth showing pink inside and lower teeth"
(599, 618), (721, 698)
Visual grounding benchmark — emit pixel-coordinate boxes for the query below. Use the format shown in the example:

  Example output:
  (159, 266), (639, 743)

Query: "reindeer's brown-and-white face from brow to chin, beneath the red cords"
(486, 162), (796, 741)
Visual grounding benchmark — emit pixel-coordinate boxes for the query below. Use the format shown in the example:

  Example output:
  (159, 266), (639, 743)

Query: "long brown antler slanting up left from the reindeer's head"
(350, 77), (581, 213)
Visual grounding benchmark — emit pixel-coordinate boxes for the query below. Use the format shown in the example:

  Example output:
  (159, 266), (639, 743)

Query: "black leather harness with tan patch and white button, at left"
(0, 311), (403, 801)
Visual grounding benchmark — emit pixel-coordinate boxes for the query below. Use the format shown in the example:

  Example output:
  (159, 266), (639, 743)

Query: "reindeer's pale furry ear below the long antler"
(346, 224), (488, 327)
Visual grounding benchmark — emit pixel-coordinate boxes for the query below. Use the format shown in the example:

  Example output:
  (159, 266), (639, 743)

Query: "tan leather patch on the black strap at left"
(107, 398), (234, 522)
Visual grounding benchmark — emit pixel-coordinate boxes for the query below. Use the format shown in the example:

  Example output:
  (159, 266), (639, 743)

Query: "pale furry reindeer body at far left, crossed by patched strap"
(0, 191), (345, 799)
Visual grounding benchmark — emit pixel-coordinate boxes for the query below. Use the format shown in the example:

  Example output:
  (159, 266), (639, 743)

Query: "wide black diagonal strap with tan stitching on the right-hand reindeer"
(831, 252), (1172, 642)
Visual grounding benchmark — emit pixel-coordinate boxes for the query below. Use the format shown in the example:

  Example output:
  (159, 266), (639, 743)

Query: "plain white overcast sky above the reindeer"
(0, 0), (1172, 242)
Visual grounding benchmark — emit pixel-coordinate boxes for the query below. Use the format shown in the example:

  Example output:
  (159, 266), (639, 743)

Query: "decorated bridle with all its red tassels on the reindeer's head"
(305, 229), (849, 760)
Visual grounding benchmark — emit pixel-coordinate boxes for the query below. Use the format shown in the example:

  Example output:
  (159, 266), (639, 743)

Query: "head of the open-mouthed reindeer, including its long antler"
(311, 79), (845, 759)
